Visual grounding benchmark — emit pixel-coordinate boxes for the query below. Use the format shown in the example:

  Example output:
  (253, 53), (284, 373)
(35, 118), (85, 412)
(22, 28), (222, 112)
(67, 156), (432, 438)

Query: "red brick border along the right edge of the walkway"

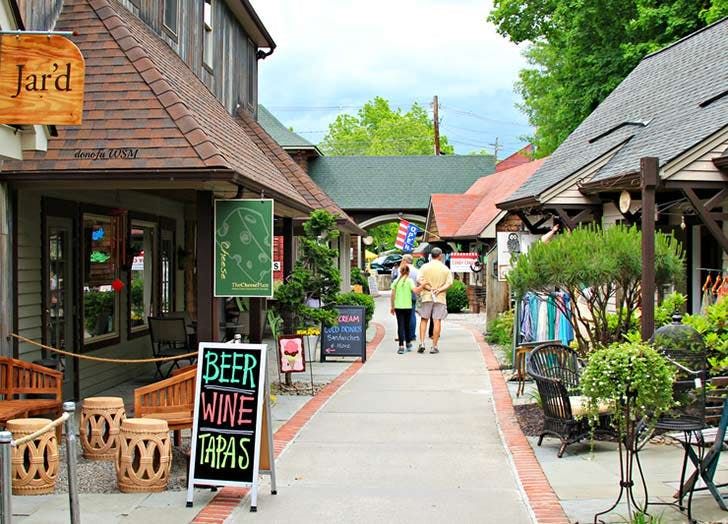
(466, 326), (569, 524)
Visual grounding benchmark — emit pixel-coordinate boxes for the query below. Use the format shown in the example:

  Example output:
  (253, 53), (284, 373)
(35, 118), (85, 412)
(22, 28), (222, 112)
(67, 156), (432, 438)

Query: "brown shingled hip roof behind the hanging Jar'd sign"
(3, 0), (310, 211)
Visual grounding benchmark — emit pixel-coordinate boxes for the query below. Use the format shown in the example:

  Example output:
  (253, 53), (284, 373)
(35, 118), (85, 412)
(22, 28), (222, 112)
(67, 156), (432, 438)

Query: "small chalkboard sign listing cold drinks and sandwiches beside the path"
(321, 306), (367, 362)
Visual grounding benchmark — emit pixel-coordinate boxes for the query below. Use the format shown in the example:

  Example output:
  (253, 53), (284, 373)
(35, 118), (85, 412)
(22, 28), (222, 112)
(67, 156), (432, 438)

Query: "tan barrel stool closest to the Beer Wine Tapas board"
(116, 418), (172, 493)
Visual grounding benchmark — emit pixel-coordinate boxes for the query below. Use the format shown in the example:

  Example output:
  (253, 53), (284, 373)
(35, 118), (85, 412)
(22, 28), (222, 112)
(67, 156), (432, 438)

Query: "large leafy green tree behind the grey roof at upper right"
(489, 0), (728, 157)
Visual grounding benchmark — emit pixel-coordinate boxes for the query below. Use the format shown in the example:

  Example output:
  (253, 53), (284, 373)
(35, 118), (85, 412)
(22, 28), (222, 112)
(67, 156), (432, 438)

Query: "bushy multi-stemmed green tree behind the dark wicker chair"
(507, 225), (684, 352)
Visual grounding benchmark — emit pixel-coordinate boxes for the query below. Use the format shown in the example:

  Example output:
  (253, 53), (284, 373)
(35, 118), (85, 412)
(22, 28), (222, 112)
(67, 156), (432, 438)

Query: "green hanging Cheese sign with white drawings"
(215, 199), (273, 297)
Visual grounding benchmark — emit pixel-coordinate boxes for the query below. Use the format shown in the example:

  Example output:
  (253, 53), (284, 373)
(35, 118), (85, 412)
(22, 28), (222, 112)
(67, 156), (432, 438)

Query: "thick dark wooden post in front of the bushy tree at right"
(640, 157), (660, 341)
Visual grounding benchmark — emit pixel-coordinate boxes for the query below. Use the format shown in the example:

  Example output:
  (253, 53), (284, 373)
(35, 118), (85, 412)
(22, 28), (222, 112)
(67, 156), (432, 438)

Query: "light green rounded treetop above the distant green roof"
(319, 97), (454, 156)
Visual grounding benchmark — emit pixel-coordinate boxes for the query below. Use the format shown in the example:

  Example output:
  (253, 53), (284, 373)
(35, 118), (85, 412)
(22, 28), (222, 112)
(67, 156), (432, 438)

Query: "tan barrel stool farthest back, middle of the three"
(80, 397), (126, 460)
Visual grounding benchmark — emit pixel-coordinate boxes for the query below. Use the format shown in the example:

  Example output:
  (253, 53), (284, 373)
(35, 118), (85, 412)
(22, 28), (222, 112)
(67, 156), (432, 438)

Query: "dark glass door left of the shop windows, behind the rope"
(44, 217), (76, 400)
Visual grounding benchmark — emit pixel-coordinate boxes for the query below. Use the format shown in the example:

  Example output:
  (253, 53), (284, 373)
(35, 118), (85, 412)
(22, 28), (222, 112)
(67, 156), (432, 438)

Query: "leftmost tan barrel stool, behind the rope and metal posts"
(7, 418), (58, 495)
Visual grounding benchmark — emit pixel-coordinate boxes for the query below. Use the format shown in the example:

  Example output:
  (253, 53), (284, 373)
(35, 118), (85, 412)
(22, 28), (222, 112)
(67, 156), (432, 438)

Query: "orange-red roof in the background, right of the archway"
(431, 159), (545, 238)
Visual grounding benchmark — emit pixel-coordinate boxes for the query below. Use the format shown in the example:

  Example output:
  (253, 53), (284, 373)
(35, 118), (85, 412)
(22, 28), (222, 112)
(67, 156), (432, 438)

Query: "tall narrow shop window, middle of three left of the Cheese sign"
(128, 220), (155, 331)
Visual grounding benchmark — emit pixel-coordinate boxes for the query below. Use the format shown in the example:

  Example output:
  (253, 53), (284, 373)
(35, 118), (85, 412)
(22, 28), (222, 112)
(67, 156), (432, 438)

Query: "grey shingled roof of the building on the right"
(502, 18), (728, 208)
